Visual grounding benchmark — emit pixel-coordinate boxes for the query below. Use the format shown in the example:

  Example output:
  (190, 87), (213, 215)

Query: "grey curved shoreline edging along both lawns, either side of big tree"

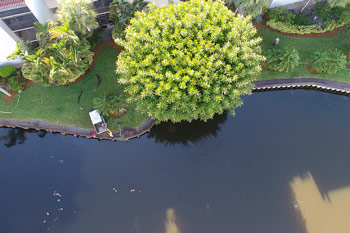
(0, 77), (350, 141)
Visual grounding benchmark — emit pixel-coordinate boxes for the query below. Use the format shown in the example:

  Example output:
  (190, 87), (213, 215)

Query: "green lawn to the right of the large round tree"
(257, 26), (350, 82)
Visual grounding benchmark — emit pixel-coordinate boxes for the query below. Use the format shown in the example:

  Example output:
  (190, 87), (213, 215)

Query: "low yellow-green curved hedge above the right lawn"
(266, 19), (345, 34)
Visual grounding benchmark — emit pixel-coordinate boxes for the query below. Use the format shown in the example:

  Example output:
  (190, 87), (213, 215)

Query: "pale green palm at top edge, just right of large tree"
(235, 0), (272, 17)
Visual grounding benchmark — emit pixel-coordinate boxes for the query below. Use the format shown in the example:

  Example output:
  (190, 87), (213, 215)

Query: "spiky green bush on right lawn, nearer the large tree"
(266, 48), (300, 72)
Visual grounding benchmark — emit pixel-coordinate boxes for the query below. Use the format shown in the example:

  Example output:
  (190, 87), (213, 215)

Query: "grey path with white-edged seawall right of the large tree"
(253, 77), (350, 94)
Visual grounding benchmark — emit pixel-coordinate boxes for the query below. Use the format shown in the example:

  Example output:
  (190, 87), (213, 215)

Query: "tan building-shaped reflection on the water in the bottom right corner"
(291, 173), (350, 233)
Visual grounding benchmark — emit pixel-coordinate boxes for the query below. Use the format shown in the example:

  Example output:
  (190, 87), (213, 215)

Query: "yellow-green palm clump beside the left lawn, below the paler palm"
(17, 23), (93, 85)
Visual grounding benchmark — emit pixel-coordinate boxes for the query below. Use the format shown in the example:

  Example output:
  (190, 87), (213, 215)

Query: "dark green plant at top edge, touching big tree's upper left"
(109, 0), (148, 39)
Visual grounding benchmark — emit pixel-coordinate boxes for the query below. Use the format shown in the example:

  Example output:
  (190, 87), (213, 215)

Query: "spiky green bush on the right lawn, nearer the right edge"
(311, 49), (346, 74)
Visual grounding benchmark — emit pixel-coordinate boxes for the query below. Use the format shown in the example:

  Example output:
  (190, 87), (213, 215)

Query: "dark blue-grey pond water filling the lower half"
(0, 90), (350, 233)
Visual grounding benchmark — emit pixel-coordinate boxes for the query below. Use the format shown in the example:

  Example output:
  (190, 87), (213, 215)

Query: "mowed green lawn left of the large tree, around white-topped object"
(0, 46), (147, 131)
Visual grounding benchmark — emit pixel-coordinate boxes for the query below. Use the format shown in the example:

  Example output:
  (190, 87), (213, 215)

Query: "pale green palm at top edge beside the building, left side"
(57, 0), (98, 36)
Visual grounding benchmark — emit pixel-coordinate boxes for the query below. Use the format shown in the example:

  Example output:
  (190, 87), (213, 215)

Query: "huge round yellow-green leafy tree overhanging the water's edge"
(117, 0), (263, 122)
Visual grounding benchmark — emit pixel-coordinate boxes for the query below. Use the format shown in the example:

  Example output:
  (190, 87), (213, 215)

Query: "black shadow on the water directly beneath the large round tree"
(147, 112), (227, 145)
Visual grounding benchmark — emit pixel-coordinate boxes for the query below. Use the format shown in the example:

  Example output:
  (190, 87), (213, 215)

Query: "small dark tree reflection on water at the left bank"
(0, 128), (47, 148)
